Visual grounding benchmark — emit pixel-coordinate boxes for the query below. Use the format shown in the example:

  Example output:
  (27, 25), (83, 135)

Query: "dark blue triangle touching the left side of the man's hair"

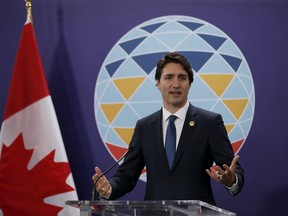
(133, 52), (166, 74)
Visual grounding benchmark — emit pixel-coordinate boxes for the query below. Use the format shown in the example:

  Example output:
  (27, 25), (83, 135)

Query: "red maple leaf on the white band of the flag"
(0, 134), (74, 216)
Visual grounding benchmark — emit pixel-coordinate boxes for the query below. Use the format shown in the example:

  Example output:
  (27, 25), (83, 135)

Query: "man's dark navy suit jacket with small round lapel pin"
(109, 104), (244, 205)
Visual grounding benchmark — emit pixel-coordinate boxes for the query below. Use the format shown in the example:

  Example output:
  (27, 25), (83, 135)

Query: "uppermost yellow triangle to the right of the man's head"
(199, 74), (234, 97)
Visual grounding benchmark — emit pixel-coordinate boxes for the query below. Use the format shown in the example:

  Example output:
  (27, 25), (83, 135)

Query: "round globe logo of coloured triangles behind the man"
(94, 16), (255, 181)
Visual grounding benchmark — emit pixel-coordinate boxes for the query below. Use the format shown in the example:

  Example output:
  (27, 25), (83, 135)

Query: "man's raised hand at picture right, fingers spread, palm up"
(206, 155), (239, 187)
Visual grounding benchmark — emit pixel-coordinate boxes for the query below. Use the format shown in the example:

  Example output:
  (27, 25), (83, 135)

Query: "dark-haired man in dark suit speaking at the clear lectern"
(92, 52), (244, 205)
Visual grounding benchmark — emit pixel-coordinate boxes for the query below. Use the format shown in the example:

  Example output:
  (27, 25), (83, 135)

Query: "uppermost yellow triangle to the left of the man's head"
(114, 77), (145, 100)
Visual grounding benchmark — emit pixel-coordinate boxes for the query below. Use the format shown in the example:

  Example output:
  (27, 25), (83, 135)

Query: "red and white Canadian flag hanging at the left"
(0, 19), (79, 216)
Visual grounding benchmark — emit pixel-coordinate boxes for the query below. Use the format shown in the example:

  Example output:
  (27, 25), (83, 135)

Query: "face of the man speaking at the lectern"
(156, 63), (191, 113)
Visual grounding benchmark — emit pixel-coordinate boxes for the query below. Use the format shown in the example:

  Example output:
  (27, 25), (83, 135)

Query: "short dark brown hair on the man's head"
(155, 52), (194, 84)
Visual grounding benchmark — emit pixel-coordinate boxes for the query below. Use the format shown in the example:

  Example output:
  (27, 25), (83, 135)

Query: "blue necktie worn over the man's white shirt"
(165, 115), (177, 170)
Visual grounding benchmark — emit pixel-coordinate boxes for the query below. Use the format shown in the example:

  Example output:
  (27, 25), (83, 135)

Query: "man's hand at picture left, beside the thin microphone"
(92, 167), (112, 198)
